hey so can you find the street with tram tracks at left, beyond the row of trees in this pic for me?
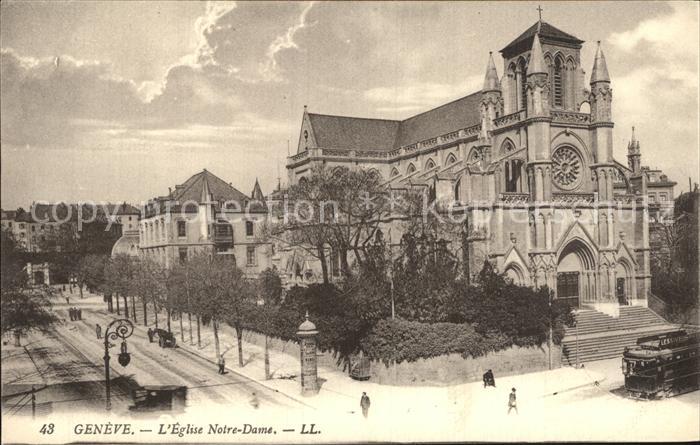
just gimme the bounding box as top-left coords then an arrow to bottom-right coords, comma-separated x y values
2,297 -> 302,411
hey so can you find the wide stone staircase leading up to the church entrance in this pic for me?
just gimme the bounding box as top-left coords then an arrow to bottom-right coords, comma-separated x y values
561,306 -> 678,365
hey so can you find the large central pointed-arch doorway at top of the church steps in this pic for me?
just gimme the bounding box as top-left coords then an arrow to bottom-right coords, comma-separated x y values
557,239 -> 596,307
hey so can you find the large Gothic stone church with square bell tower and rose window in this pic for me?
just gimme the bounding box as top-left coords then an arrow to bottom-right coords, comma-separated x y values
287,21 -> 672,312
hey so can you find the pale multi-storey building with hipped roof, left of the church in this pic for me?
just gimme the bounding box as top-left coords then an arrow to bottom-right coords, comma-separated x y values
138,169 -> 271,276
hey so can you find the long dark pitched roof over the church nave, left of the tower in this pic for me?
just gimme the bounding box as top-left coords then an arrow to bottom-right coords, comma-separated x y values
308,92 -> 481,151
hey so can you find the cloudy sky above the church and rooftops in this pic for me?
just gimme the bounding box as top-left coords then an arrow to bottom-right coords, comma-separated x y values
0,1 -> 700,209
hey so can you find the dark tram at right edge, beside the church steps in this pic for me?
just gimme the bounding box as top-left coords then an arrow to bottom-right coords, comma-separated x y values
622,330 -> 700,399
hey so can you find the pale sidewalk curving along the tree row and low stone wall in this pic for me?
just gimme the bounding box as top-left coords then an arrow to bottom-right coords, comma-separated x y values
75,294 -> 605,415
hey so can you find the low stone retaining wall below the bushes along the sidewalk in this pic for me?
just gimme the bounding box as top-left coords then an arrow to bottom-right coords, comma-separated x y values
243,331 -> 561,386
